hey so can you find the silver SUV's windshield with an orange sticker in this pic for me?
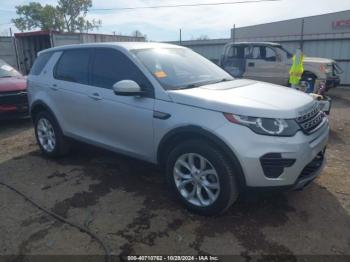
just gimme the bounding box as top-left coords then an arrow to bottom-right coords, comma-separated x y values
133,48 -> 233,90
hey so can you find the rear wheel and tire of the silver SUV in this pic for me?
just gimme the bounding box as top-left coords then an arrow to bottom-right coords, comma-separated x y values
34,111 -> 70,158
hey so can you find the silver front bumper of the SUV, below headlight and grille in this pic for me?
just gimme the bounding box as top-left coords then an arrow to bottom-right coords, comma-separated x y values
216,121 -> 329,189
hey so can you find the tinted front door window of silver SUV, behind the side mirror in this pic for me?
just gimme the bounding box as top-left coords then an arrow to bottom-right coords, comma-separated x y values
91,48 -> 152,91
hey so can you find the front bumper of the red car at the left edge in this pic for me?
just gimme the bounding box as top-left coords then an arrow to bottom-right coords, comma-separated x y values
0,92 -> 29,120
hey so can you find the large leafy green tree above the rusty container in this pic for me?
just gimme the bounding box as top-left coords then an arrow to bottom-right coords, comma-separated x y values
12,0 -> 102,32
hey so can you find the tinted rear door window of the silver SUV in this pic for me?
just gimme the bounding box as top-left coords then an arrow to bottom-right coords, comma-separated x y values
55,49 -> 90,84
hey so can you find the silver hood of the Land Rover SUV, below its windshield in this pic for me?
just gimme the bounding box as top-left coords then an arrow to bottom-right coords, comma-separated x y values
168,79 -> 314,119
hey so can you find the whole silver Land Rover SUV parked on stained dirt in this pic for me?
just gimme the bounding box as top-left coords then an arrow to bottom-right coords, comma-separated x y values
28,43 -> 329,215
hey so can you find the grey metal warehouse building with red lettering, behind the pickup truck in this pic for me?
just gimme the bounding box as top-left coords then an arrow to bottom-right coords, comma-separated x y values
177,10 -> 350,85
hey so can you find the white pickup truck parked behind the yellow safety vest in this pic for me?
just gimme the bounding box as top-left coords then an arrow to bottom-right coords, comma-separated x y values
219,42 -> 342,90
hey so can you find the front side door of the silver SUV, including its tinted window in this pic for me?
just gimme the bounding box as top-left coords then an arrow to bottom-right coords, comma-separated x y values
85,48 -> 154,160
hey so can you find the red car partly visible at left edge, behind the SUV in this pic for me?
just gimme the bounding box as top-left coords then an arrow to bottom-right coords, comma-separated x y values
0,59 -> 29,120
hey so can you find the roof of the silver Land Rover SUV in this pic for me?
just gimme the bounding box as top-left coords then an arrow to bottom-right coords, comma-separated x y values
39,42 -> 185,54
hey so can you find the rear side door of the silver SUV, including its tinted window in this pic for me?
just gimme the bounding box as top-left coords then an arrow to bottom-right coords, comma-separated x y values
50,48 -> 92,138
